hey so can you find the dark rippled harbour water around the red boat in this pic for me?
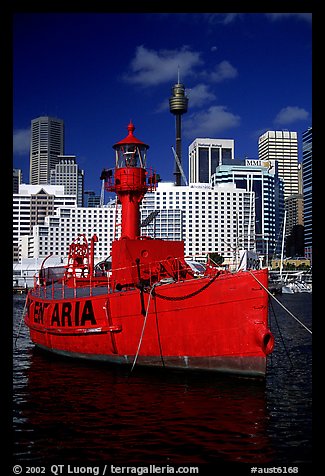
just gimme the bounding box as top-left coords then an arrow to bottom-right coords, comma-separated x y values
11,293 -> 312,474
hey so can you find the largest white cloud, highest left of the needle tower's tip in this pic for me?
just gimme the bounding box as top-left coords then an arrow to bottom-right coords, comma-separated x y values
124,46 -> 202,86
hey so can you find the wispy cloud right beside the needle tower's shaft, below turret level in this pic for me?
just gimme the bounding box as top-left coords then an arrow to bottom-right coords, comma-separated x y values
183,106 -> 240,138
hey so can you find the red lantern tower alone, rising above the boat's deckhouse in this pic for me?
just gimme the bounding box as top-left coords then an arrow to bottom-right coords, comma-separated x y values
111,121 -> 149,240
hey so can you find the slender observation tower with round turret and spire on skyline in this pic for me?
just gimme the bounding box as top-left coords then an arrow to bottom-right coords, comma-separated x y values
169,73 -> 188,185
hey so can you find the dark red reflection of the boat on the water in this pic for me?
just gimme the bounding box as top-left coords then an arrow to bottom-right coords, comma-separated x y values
15,350 -> 273,464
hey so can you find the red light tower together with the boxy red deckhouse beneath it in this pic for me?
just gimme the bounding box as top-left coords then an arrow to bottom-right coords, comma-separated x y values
107,122 -> 187,289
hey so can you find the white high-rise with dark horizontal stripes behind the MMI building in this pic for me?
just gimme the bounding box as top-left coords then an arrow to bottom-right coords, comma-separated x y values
258,131 -> 299,199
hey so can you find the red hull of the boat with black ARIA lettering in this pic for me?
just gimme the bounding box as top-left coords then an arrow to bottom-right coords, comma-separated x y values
25,269 -> 274,376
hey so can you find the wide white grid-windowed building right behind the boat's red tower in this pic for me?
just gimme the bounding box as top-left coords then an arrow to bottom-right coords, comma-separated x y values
141,182 -> 256,262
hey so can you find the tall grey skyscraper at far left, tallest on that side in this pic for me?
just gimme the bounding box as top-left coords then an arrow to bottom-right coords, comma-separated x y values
29,116 -> 64,185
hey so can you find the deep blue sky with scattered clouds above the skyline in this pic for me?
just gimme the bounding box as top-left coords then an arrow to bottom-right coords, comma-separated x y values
13,13 -> 312,194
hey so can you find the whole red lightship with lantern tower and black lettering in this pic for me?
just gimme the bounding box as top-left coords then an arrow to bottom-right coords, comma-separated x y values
25,123 -> 274,377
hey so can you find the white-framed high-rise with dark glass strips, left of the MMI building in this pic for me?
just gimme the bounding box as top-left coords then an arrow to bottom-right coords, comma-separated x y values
188,138 -> 235,184
